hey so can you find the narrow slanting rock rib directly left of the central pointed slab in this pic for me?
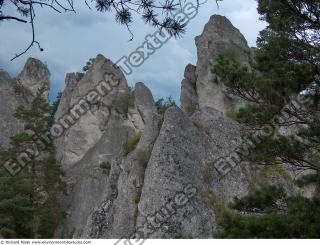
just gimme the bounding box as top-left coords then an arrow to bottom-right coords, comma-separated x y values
86,114 -> 161,238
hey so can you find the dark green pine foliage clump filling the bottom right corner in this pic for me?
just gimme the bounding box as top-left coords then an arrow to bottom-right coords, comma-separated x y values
219,187 -> 320,238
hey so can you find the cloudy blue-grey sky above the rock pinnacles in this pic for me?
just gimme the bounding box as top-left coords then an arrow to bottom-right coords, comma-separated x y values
0,0 -> 265,101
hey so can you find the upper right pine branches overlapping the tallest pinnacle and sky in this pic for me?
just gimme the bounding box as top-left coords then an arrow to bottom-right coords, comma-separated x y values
213,0 -> 320,170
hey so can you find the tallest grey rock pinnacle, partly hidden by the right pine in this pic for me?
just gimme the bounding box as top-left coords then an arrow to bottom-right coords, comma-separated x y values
181,15 -> 252,113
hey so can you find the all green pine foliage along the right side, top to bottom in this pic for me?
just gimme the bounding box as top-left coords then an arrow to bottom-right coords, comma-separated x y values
213,0 -> 320,238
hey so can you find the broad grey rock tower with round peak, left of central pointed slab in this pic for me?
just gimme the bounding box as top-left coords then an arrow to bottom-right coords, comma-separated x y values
55,55 -> 160,238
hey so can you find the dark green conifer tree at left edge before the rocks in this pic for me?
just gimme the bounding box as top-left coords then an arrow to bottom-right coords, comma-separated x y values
0,86 -> 65,238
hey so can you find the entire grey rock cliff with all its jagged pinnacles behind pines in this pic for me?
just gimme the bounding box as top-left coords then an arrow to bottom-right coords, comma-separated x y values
0,16 -> 308,238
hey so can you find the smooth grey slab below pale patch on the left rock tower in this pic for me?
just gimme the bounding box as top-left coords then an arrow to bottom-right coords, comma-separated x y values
56,114 -> 128,238
